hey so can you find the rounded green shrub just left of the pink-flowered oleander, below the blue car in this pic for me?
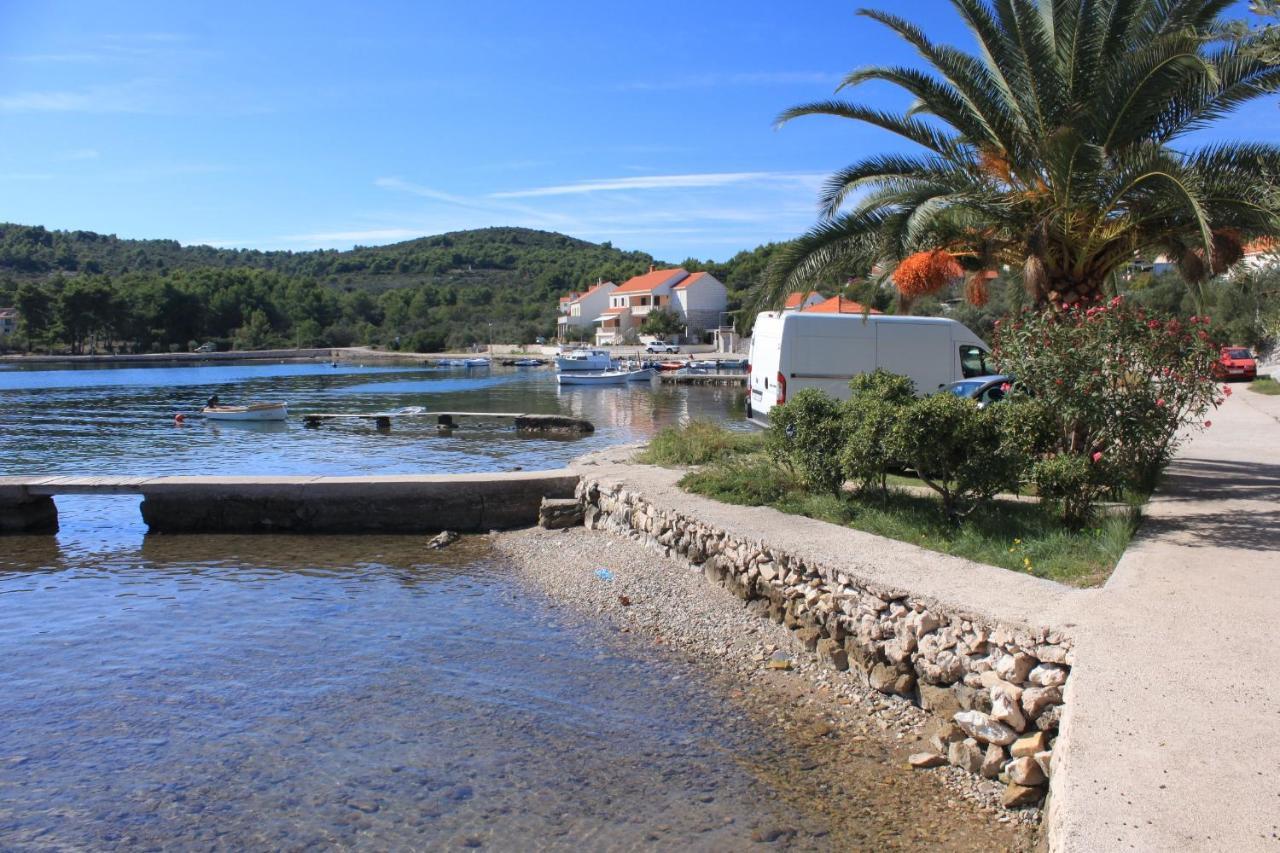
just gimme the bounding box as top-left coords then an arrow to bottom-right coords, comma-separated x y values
886,394 -> 1020,520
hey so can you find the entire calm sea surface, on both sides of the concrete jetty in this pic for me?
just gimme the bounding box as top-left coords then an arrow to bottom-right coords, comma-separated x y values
0,364 -> 820,849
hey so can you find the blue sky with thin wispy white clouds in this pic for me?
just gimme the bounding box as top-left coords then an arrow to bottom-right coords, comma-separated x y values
0,0 -> 1280,261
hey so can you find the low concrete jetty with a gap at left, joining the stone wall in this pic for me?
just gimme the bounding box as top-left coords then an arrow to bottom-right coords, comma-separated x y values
0,469 -> 579,533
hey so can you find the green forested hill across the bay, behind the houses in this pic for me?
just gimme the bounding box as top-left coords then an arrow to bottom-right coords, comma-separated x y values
0,224 -> 774,352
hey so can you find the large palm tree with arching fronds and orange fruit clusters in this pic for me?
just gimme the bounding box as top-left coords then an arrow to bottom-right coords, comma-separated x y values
756,0 -> 1280,307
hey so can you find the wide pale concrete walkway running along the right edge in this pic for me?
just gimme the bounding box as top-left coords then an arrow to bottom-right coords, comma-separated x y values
1050,386 -> 1280,852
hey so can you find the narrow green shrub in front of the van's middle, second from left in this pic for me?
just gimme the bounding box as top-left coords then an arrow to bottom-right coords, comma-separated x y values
840,369 -> 915,498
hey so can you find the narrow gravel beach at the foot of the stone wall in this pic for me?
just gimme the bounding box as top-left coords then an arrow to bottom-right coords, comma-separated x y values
492,528 -> 1038,850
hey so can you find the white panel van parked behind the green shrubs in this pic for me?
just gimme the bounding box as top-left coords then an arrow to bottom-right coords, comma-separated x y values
746,311 -> 995,427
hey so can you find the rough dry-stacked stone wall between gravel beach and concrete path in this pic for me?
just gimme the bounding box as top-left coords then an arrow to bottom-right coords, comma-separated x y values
577,473 -> 1073,808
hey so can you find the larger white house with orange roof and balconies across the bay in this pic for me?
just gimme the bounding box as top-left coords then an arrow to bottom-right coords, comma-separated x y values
595,269 -> 728,345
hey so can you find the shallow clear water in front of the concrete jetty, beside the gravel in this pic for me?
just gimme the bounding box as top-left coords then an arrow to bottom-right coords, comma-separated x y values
0,535 -> 860,849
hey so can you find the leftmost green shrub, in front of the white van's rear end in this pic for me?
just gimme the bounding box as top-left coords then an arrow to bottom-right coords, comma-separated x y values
765,388 -> 846,494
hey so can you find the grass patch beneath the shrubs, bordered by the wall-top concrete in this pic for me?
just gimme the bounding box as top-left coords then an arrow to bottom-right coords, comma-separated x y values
680,453 -> 1138,587
